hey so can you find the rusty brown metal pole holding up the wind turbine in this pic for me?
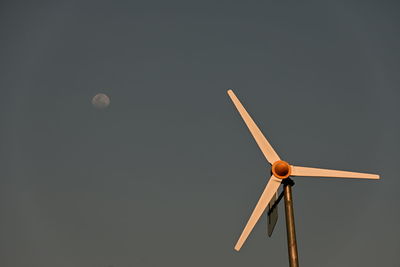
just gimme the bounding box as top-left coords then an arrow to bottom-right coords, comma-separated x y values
283,178 -> 299,267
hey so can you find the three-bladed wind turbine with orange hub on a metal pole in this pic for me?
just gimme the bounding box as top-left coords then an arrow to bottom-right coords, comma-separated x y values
228,90 -> 380,267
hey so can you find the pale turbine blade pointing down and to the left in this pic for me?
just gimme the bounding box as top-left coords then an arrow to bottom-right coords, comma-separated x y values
235,175 -> 282,251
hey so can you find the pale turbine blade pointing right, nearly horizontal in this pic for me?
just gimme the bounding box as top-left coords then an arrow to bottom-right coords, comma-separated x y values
291,166 -> 380,179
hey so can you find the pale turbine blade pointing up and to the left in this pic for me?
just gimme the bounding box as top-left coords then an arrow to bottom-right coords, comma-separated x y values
228,90 -> 280,164
